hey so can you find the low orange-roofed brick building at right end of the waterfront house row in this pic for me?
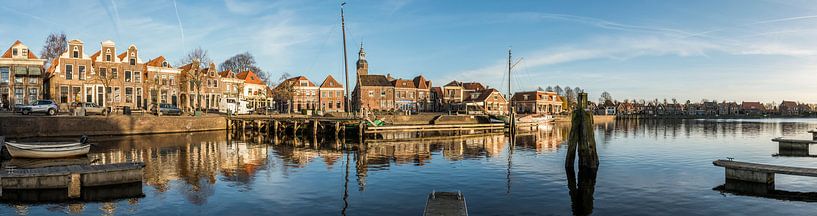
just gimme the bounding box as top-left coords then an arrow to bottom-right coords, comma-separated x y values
511,91 -> 562,114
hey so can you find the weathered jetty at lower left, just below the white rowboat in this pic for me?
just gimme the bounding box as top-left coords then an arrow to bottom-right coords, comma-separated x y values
0,162 -> 145,197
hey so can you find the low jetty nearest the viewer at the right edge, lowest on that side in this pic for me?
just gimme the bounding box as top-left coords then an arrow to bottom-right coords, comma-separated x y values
712,160 -> 817,186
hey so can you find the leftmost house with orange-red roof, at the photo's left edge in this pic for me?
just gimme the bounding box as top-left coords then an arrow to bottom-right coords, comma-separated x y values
0,40 -> 45,109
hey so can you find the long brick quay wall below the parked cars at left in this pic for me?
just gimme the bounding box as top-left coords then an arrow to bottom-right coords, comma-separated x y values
0,116 -> 227,138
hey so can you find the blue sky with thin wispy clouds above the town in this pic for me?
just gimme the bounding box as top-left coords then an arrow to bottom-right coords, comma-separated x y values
0,0 -> 817,103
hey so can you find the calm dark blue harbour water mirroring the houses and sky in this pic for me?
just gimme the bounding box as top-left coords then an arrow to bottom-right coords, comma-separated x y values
0,120 -> 817,215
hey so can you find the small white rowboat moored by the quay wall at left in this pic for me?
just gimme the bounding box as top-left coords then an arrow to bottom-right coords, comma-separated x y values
0,137 -> 91,158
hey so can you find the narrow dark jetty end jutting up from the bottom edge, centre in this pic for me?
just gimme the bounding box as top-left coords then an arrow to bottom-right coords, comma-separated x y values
423,192 -> 468,216
